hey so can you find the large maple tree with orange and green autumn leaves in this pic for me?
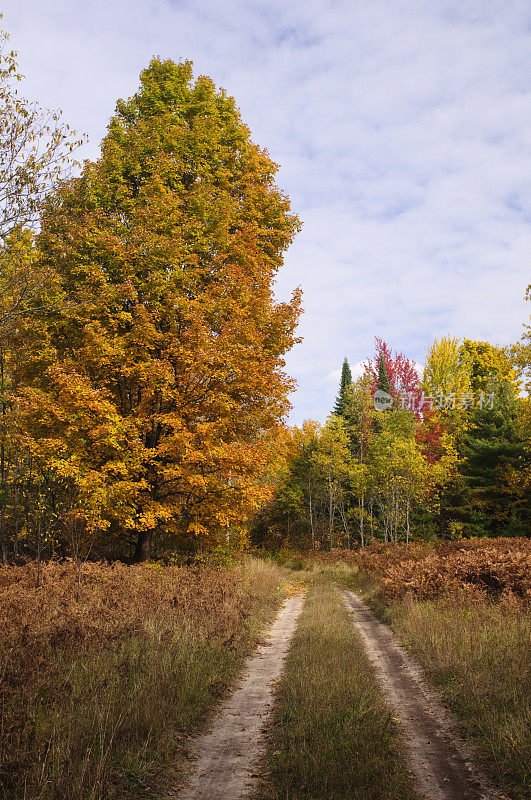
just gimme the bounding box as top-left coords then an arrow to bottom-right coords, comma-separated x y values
18,58 -> 300,560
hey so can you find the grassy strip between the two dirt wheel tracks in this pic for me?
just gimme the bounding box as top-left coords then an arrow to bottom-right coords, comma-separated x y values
258,582 -> 415,800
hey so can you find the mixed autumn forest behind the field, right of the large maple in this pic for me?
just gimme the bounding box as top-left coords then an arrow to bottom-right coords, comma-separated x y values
253,332 -> 531,549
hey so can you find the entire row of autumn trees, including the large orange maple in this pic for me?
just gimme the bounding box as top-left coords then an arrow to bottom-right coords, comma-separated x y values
0,25 -> 531,563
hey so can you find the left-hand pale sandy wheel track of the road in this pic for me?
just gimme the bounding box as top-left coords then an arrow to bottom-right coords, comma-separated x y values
166,595 -> 304,800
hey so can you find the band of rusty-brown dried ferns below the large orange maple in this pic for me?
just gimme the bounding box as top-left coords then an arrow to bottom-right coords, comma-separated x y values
0,562 -> 254,647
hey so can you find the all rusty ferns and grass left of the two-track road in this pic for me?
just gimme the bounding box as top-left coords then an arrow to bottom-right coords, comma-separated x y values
0,561 -> 281,800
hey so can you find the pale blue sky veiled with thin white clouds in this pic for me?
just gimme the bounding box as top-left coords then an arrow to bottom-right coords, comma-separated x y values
2,0 -> 531,422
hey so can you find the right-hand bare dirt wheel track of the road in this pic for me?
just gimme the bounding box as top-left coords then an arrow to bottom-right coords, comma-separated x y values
344,592 -> 503,800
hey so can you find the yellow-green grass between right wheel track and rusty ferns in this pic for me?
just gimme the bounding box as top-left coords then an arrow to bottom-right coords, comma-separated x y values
389,598 -> 531,800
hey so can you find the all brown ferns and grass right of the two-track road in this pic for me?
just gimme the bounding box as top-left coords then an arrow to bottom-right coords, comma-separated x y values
290,539 -> 531,800
